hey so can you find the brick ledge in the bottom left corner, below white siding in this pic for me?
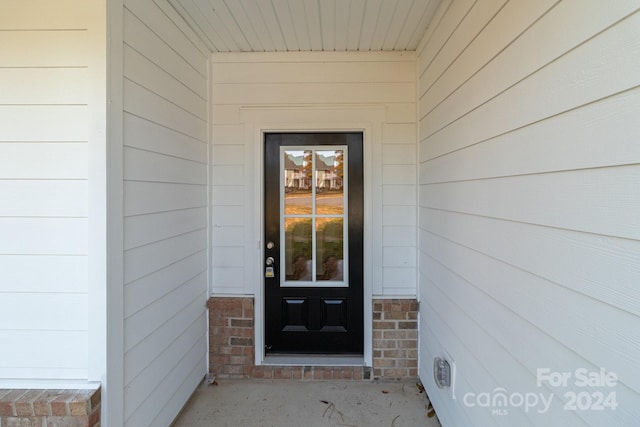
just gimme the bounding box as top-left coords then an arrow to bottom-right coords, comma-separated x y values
0,389 -> 101,427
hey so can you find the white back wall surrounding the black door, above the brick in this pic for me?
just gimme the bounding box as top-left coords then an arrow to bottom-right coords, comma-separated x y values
211,52 -> 417,300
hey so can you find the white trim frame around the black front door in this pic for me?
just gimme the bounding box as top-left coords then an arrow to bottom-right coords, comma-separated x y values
252,123 -> 381,366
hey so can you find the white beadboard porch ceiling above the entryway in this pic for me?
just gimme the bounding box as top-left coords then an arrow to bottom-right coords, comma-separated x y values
169,0 -> 441,52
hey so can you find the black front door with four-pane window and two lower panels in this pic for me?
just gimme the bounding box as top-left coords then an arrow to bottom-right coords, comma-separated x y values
263,133 -> 363,354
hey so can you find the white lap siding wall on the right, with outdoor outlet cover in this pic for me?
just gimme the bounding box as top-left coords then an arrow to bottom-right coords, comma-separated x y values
418,0 -> 640,426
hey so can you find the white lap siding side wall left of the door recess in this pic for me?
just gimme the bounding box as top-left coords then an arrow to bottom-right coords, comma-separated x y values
123,0 -> 208,427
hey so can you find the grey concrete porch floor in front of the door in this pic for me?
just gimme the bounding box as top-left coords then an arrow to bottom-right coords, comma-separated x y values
173,379 -> 440,427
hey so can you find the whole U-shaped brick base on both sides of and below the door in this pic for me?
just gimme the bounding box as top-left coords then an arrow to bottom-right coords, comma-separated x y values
210,297 -> 418,382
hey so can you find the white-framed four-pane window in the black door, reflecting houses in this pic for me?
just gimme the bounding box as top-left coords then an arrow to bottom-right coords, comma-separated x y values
280,146 -> 348,286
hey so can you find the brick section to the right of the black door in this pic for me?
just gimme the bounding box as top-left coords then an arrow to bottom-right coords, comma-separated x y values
373,299 -> 418,379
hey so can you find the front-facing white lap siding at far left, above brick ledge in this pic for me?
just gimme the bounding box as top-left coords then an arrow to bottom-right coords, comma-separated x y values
0,0 -> 91,380
